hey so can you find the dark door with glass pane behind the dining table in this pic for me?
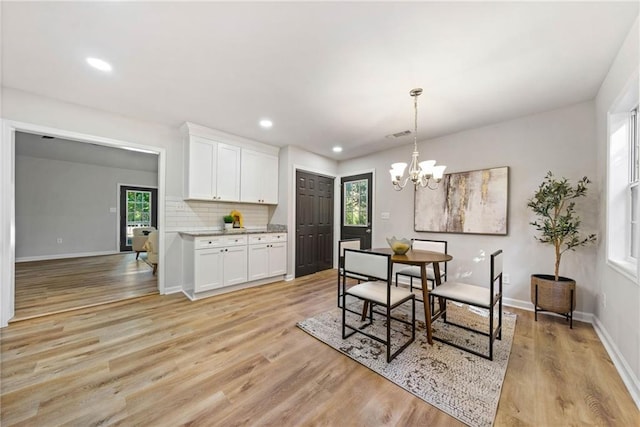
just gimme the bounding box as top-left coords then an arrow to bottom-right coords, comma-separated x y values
340,173 -> 373,249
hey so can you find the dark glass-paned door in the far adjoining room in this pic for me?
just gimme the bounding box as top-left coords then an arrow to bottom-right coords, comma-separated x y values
120,185 -> 158,252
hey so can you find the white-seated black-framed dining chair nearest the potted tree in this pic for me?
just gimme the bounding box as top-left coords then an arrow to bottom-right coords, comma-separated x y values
429,249 -> 502,360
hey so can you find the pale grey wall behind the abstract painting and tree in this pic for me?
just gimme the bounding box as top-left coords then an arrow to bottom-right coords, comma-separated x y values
339,102 -> 599,314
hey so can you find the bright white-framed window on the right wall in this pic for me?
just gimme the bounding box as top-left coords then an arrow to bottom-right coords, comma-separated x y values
607,99 -> 640,281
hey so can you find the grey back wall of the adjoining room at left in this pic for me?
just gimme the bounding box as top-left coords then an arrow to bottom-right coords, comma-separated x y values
15,156 -> 158,261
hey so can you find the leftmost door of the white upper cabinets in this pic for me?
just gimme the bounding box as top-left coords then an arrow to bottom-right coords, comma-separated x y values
185,136 -> 217,200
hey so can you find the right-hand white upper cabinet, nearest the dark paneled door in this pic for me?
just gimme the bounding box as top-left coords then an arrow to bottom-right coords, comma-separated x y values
240,148 -> 278,205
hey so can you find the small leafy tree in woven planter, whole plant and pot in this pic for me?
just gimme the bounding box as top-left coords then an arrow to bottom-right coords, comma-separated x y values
527,172 -> 596,327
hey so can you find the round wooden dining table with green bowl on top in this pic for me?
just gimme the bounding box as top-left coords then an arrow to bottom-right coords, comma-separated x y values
371,248 -> 453,344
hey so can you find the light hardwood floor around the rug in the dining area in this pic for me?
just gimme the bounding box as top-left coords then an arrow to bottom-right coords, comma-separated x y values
0,270 -> 640,427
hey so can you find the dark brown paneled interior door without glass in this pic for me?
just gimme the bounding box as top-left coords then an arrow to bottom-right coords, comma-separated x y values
296,171 -> 333,277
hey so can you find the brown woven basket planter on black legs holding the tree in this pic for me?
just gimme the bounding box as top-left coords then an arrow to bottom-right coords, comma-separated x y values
531,274 -> 576,327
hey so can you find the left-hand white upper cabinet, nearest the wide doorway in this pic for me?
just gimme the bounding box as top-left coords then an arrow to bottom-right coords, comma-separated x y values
184,136 -> 240,202
